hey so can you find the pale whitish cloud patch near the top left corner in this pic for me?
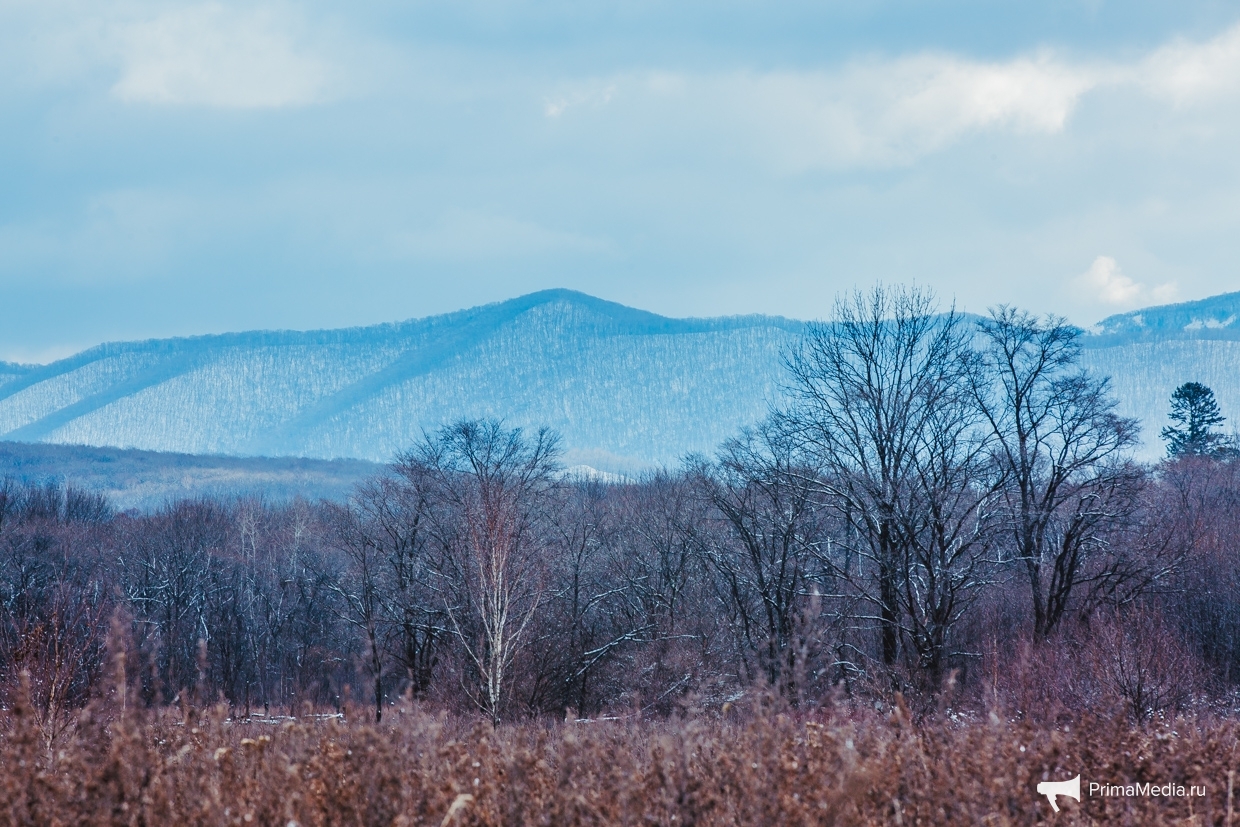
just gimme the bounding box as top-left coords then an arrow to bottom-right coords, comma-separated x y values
112,4 -> 329,109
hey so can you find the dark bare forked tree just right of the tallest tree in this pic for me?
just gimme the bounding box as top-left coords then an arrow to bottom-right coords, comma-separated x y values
973,307 -> 1141,639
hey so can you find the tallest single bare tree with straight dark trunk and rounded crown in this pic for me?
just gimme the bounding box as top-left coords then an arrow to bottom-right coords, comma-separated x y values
780,286 -> 967,666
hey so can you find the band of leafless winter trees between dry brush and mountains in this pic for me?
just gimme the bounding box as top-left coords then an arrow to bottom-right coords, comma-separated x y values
0,288 -> 1240,722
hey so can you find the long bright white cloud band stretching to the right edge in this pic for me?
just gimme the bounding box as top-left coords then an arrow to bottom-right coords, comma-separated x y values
543,25 -> 1240,172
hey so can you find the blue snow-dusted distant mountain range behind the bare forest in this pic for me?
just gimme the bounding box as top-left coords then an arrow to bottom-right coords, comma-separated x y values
0,290 -> 1240,474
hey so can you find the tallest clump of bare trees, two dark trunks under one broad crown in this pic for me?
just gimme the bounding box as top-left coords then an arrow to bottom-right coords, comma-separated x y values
776,288 -> 1002,682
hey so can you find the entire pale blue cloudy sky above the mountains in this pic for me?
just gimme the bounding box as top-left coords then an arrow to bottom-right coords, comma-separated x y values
0,0 -> 1240,362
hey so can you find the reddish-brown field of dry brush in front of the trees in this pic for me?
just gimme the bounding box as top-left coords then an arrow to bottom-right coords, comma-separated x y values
0,679 -> 1240,827
